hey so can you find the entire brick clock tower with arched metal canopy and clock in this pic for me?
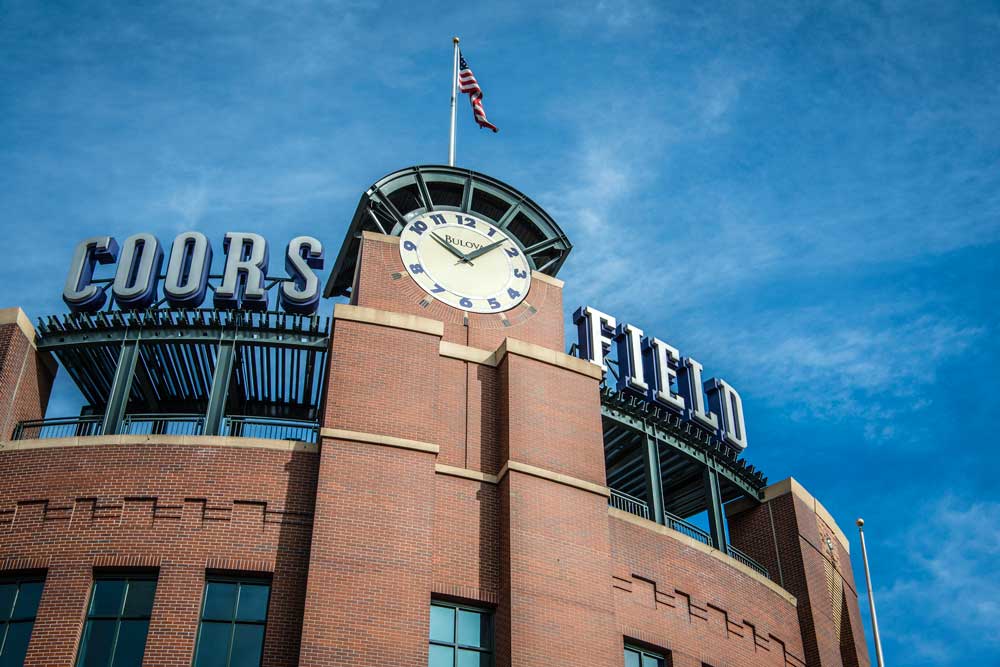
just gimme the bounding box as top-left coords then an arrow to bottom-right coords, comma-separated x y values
300,166 -> 621,667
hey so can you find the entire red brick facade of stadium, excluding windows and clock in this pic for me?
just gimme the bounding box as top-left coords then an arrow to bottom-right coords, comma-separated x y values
0,234 -> 868,667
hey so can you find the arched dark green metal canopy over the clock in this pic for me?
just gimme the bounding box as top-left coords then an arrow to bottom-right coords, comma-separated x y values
324,165 -> 573,297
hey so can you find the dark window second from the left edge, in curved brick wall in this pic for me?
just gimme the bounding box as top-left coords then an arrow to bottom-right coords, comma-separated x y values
76,574 -> 156,667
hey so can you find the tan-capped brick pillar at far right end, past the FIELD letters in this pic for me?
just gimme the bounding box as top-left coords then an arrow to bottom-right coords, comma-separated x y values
727,478 -> 870,667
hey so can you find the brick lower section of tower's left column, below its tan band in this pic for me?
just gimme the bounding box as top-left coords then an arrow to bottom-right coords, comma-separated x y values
299,438 -> 436,667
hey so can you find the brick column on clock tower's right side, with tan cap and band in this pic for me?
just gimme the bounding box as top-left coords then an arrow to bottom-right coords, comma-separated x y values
497,339 -> 622,667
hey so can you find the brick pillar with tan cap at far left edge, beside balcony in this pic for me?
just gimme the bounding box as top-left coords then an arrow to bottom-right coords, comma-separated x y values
0,308 -> 57,440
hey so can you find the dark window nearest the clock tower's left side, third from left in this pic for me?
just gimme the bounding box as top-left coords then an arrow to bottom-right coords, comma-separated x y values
194,576 -> 271,667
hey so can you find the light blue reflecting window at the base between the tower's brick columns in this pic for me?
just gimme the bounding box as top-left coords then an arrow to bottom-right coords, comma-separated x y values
427,602 -> 493,667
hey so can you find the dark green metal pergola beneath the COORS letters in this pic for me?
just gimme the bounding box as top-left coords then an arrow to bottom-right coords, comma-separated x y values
37,308 -> 330,434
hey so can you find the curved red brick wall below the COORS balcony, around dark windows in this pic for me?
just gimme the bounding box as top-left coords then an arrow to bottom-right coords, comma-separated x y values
0,439 -> 318,667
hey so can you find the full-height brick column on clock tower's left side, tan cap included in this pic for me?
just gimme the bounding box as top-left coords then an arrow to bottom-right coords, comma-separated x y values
299,305 -> 442,667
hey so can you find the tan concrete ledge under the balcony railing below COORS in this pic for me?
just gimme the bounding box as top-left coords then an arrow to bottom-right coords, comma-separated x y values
0,435 -> 319,454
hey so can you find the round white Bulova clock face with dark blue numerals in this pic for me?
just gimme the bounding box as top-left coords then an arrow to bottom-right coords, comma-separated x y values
399,211 -> 531,313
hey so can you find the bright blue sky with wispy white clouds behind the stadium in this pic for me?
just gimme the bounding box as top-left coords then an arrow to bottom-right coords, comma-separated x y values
0,0 -> 1000,667
